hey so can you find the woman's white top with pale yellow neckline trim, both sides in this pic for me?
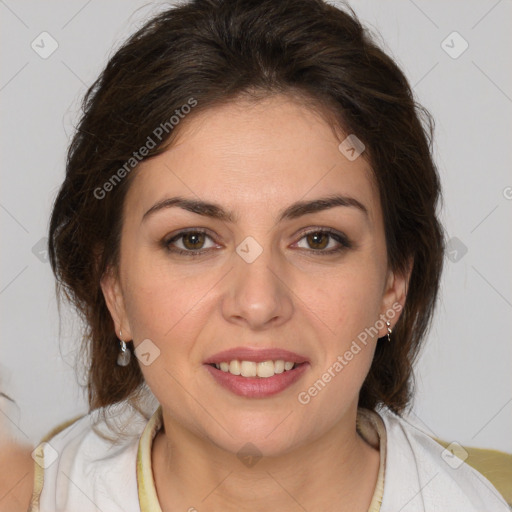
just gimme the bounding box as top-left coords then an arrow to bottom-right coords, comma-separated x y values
29,407 -> 510,512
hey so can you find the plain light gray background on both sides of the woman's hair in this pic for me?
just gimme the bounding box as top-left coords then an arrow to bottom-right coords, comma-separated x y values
0,0 -> 512,452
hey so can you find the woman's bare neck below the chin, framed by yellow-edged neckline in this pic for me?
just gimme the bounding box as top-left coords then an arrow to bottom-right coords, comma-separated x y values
152,408 -> 379,512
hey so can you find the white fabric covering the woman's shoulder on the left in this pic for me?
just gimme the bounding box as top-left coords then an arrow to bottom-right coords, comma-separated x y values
30,404 -> 148,512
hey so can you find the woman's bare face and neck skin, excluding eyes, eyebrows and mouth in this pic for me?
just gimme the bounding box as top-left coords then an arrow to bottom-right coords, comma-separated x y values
102,95 -> 408,512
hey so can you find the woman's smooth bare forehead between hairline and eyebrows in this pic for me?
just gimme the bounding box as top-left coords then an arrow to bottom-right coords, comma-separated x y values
126,96 -> 379,226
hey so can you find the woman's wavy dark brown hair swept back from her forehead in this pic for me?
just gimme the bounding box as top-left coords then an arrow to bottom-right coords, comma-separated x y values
49,0 -> 444,420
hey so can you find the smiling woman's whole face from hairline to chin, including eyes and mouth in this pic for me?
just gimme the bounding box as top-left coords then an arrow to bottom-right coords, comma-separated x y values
102,96 -> 405,455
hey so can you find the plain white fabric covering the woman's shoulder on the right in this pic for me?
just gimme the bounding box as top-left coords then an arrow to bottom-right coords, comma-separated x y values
378,408 -> 509,512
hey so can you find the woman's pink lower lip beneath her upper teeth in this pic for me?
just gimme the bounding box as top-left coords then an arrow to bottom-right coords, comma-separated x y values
205,363 -> 309,398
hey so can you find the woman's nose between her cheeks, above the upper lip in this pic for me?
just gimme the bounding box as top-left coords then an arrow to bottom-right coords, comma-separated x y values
222,242 -> 293,330
